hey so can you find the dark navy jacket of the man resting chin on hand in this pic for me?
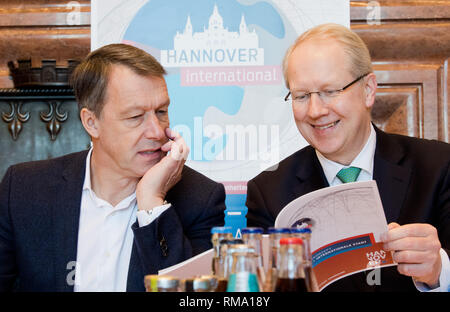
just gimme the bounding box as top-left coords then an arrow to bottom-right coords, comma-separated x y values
0,151 -> 225,291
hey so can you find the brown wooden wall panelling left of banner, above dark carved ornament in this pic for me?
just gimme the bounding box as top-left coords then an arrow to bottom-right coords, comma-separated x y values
0,0 -> 90,88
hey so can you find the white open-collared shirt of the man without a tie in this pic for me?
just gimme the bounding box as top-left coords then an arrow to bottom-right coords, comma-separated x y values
74,148 -> 170,292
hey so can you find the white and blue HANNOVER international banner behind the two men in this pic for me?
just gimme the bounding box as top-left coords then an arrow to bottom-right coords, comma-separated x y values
91,0 -> 350,234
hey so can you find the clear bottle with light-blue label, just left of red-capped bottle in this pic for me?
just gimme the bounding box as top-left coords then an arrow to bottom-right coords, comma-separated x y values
227,245 -> 261,292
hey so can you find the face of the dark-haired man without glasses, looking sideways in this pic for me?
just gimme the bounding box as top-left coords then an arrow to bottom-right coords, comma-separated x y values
90,65 -> 170,178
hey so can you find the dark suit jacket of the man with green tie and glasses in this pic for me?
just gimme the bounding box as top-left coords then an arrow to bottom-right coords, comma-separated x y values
246,128 -> 450,291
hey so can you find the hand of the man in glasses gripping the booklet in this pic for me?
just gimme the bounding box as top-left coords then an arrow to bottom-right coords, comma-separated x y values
381,223 -> 442,287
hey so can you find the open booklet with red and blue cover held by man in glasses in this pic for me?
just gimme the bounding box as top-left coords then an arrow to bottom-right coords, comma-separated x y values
275,181 -> 396,290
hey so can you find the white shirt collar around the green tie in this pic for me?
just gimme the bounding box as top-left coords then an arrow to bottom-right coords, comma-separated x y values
315,124 -> 377,185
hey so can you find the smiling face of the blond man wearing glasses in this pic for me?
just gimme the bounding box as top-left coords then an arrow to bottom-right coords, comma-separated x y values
287,39 -> 376,165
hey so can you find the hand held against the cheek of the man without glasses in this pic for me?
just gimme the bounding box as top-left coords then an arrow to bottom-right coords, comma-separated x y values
136,128 -> 189,210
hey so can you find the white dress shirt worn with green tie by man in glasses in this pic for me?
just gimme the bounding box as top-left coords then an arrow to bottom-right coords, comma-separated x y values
316,124 -> 450,292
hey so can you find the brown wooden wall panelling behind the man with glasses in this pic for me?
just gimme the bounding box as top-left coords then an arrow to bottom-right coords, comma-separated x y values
350,0 -> 450,142
